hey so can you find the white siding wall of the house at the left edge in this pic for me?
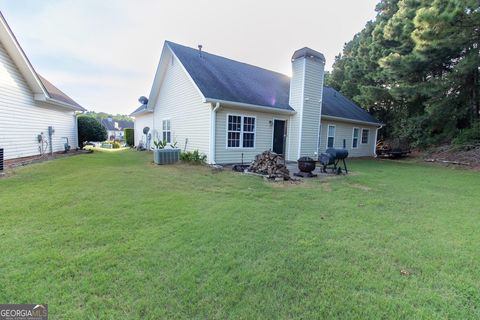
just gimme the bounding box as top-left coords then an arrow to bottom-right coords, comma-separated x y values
0,44 -> 78,159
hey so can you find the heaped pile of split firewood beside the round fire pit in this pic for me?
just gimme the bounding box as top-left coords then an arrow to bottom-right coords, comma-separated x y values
248,151 -> 290,180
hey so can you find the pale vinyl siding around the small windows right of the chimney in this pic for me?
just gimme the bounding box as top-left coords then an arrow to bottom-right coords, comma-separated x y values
319,119 -> 376,157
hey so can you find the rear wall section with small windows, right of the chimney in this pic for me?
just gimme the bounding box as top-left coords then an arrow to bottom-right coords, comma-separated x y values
319,119 -> 377,157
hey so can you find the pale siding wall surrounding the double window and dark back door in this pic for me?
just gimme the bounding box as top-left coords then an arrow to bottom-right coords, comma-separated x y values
215,106 -> 290,164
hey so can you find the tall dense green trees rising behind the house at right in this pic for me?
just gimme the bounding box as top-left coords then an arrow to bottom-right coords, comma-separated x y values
328,0 -> 480,145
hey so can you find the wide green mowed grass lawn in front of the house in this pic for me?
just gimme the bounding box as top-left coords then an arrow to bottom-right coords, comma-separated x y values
0,151 -> 480,319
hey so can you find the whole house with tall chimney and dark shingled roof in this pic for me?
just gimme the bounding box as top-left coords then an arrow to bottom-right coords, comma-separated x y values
132,41 -> 382,163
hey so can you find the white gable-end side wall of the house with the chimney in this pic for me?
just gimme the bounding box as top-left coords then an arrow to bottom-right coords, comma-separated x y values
152,50 -> 211,158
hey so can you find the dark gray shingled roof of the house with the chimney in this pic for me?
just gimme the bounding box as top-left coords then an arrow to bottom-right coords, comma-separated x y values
164,41 -> 380,124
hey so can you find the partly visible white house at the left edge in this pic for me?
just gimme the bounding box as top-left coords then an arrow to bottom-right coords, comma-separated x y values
0,13 -> 85,159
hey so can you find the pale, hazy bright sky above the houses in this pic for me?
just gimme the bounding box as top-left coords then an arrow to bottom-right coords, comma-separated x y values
0,0 -> 378,114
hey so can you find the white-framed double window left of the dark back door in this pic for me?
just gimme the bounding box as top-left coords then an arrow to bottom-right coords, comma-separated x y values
227,115 -> 255,148
